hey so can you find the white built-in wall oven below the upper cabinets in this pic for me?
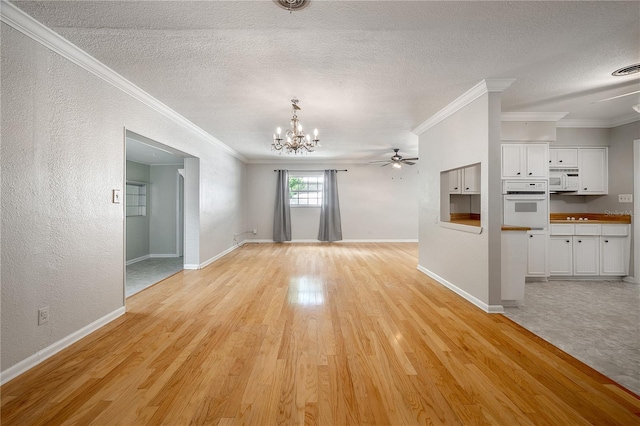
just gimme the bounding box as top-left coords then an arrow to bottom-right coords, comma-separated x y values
502,180 -> 549,229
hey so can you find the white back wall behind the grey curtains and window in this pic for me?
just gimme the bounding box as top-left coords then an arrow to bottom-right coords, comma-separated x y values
247,160 -> 421,241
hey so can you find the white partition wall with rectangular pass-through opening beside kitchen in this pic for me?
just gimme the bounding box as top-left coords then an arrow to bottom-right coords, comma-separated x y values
419,92 -> 502,306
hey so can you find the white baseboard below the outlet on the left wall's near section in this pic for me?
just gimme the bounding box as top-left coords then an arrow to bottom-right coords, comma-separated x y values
0,306 -> 126,385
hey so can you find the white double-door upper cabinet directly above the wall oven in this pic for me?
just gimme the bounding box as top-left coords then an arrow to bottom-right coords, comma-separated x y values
502,143 -> 549,179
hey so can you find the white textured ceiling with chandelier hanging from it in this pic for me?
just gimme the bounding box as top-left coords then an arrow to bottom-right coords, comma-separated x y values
14,0 -> 640,161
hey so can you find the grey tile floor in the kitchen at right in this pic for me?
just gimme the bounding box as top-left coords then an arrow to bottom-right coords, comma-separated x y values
505,281 -> 640,394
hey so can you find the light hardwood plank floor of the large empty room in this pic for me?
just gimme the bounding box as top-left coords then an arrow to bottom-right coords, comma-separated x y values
0,243 -> 640,425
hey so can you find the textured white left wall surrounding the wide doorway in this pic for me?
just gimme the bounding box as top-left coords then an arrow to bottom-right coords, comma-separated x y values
0,22 -> 246,380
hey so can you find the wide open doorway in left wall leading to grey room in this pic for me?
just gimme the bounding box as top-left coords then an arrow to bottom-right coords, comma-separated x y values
124,130 -> 199,298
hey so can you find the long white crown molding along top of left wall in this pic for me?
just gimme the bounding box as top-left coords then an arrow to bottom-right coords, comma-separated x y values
0,0 -> 247,163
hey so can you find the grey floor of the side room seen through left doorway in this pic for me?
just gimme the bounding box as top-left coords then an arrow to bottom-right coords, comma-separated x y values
125,257 -> 183,297
